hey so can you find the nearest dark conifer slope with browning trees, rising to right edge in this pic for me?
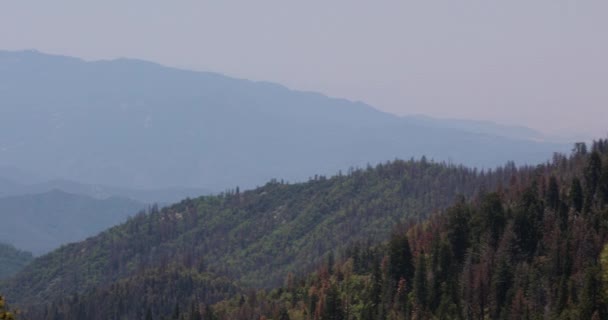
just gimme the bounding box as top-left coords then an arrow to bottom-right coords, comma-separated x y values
207,140 -> 608,320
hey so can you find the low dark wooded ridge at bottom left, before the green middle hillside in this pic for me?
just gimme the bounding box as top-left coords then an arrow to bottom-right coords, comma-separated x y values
35,265 -> 238,320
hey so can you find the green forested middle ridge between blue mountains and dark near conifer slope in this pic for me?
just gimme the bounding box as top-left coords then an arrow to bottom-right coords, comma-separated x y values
0,159 -> 517,317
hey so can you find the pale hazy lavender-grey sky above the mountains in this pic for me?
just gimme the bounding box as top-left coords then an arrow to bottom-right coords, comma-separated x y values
0,0 -> 608,137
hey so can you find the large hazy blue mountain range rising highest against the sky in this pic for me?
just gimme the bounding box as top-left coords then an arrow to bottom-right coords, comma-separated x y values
0,51 -> 569,190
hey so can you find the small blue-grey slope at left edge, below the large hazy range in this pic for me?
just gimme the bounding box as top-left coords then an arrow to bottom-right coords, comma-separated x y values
0,190 -> 143,255
